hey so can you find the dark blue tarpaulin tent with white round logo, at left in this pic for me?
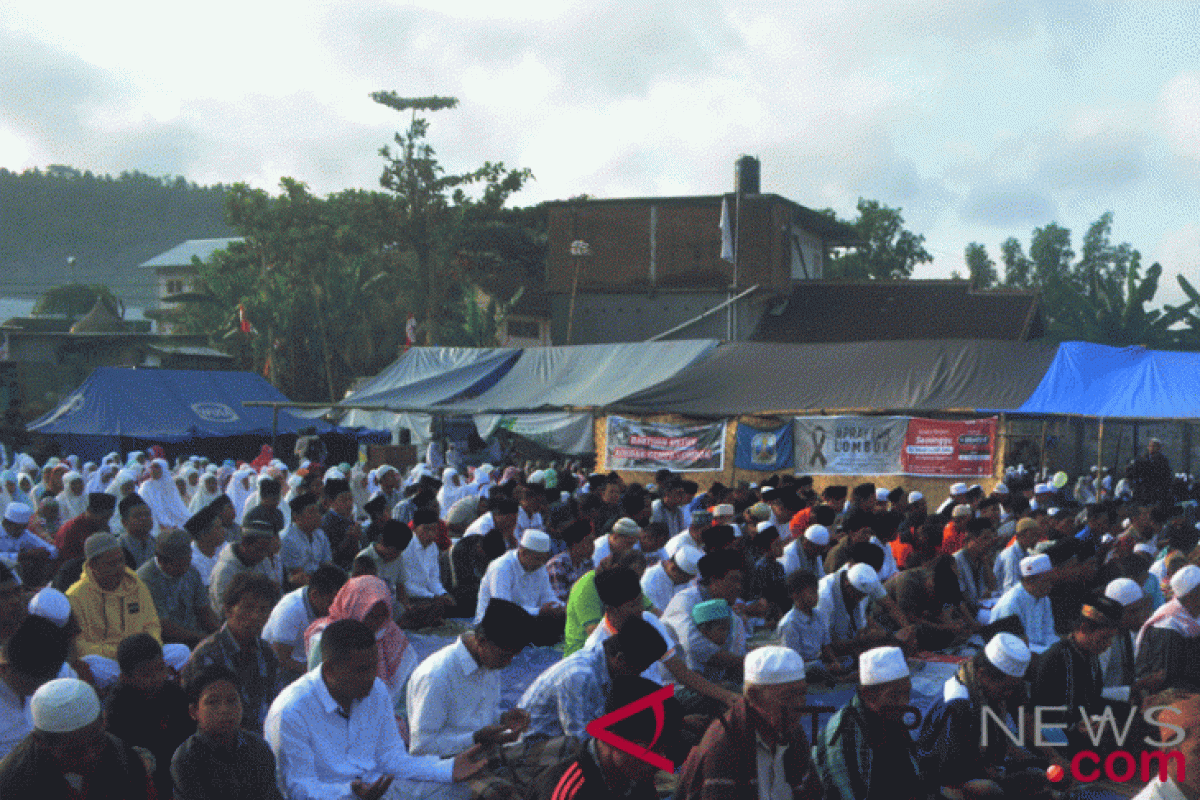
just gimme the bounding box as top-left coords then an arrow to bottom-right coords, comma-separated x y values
28,367 -> 332,462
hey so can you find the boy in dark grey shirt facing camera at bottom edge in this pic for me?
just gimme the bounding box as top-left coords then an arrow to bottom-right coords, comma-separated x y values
171,666 -> 282,800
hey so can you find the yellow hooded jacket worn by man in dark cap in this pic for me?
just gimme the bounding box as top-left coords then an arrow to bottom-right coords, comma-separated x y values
66,565 -> 162,660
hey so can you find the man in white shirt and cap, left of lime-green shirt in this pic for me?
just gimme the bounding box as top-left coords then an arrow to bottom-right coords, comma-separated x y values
475,528 -> 566,645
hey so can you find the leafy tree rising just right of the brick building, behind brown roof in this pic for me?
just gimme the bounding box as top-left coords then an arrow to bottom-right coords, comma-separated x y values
826,198 -> 934,281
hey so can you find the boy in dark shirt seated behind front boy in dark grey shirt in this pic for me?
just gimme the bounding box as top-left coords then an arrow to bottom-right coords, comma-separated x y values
104,633 -> 196,798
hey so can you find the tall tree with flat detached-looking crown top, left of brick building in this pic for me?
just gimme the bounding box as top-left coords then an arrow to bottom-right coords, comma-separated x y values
371,91 -> 533,344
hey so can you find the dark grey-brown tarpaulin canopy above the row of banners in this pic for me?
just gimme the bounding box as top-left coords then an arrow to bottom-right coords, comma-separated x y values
614,338 -> 1057,417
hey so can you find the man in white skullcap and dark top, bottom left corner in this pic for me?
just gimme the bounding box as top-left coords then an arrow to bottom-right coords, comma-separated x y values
0,678 -> 155,800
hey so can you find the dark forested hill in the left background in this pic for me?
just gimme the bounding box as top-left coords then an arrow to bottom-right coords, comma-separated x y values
0,166 -> 234,306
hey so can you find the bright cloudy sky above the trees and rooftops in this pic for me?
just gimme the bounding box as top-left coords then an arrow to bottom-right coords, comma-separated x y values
0,0 -> 1200,300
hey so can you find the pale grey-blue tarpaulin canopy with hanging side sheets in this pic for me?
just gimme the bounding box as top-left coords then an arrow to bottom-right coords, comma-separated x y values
331,339 -> 718,453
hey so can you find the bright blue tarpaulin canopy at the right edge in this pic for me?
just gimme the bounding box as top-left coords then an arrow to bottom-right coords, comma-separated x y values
986,342 -> 1200,420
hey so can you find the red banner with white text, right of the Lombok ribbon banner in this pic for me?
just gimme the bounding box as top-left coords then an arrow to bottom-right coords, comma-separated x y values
900,416 -> 996,477
